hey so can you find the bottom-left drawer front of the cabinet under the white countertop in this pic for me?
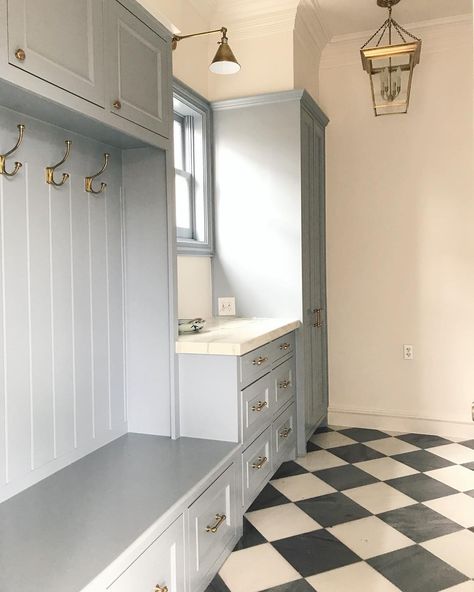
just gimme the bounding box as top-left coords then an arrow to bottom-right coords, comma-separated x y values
242,427 -> 272,508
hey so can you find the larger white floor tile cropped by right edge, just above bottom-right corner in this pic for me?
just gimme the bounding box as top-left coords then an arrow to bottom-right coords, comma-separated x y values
421,530 -> 474,578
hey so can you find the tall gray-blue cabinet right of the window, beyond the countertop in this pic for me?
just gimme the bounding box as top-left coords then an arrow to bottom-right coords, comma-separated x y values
213,91 -> 328,454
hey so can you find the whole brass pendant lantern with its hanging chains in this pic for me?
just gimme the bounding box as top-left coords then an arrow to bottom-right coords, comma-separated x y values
360,0 -> 421,117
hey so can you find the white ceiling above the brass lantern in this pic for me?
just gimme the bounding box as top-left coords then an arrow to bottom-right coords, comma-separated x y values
317,0 -> 472,38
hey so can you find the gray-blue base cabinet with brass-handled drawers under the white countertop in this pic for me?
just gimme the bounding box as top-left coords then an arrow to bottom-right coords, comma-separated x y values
179,332 -> 296,510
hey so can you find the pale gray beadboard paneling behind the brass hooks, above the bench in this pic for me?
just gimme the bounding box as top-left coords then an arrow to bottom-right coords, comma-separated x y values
0,108 -> 127,501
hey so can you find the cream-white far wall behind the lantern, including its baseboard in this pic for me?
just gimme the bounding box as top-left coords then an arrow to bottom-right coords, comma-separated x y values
320,16 -> 474,435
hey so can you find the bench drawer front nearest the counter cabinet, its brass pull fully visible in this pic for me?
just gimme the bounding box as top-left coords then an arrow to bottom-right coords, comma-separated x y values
188,465 -> 236,590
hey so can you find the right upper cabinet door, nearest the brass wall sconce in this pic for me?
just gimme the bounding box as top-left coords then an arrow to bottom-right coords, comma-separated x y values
106,0 -> 171,137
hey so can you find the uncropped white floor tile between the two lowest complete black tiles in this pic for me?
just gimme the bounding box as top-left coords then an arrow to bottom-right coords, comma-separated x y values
328,516 -> 414,559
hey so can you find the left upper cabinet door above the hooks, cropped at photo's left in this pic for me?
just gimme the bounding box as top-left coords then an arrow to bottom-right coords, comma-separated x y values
8,0 -> 105,106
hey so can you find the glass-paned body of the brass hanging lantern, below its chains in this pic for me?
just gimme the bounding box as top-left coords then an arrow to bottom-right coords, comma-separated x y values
360,40 -> 421,117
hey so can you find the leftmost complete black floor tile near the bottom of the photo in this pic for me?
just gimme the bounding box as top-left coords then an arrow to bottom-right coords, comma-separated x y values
272,530 -> 360,577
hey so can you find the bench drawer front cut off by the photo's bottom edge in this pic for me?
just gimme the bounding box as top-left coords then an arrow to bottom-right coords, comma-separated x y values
107,516 -> 184,592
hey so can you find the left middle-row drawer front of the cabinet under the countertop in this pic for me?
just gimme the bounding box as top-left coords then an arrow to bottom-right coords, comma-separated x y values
241,374 -> 275,443
